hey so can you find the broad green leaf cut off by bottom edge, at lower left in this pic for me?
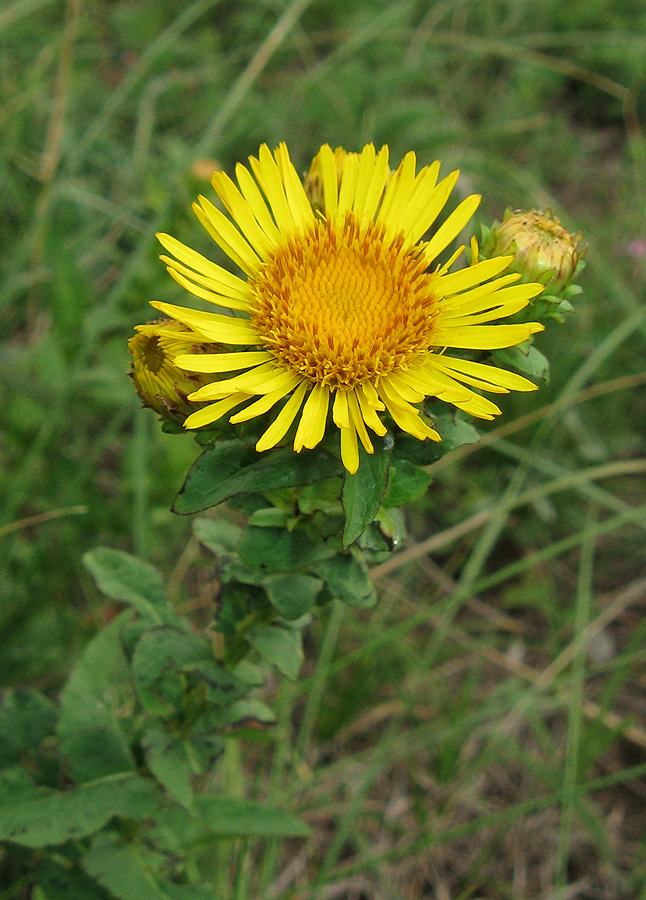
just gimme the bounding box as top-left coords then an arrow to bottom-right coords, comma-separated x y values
83,832 -> 172,900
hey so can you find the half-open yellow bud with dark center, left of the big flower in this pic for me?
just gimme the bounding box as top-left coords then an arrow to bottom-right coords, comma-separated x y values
128,319 -> 220,425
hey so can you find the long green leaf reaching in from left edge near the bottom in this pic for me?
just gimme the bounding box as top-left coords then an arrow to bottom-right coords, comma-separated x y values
0,772 -> 161,848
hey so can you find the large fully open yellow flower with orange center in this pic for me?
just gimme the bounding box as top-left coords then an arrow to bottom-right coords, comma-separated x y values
152,144 -> 543,473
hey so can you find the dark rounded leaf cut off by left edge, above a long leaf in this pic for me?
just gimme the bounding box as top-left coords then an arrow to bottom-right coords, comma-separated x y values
0,688 -> 56,768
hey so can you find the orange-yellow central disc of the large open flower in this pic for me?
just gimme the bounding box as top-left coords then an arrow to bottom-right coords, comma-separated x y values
252,214 -> 439,389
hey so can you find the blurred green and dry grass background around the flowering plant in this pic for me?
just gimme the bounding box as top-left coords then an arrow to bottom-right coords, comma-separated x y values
0,0 -> 646,900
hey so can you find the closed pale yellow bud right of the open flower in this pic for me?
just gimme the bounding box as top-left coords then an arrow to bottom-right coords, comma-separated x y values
484,209 -> 586,294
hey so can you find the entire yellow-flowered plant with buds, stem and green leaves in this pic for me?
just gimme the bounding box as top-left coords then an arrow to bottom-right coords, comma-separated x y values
0,144 -> 582,900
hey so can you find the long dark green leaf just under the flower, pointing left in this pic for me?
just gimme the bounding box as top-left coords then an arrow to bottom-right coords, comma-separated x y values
173,440 -> 340,515
